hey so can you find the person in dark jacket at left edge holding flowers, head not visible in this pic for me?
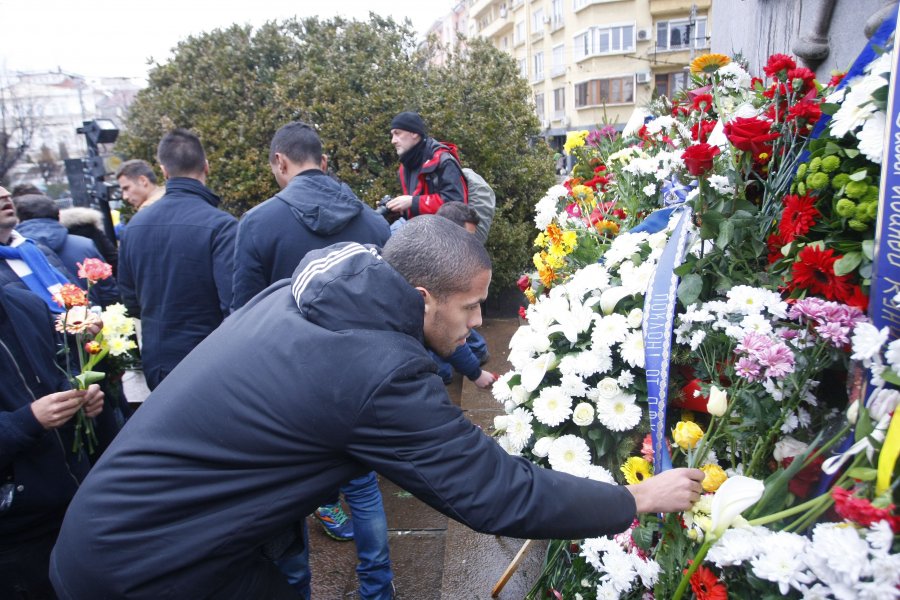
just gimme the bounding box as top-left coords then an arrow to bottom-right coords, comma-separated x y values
0,286 -> 103,600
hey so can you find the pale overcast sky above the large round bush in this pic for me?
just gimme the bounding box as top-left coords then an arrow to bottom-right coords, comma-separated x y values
0,0 -> 453,78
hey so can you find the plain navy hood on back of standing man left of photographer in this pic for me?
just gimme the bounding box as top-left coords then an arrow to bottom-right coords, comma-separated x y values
275,174 -> 364,235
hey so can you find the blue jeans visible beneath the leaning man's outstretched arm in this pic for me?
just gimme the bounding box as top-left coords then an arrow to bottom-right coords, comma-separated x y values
278,471 -> 394,600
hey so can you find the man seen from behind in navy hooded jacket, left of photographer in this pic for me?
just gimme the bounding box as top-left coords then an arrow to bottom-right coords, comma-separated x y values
232,121 -> 391,309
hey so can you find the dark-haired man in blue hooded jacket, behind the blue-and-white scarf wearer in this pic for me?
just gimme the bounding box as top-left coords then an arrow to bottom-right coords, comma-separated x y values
14,194 -> 119,307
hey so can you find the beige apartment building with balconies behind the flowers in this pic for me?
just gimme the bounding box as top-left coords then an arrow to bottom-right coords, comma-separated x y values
468,0 -> 712,148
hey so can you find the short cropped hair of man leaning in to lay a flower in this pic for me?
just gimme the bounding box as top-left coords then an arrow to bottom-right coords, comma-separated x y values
382,215 -> 491,300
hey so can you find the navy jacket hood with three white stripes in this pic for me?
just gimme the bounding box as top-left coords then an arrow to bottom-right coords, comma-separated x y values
291,242 -> 425,342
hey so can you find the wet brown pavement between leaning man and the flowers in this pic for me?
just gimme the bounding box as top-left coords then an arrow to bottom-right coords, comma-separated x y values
308,318 -> 544,600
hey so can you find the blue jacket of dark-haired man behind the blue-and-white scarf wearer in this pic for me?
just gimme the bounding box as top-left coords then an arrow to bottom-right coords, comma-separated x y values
16,219 -> 120,308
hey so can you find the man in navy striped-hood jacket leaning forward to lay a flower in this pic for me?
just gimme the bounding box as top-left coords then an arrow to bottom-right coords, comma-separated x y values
50,216 -> 704,600
